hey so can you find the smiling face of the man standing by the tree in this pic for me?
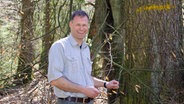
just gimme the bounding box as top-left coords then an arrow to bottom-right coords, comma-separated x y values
69,16 -> 89,41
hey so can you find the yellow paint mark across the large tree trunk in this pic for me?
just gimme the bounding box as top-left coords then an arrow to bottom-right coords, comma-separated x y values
136,4 -> 175,12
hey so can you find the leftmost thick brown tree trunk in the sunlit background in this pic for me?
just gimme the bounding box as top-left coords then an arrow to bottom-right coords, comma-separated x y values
15,0 -> 34,84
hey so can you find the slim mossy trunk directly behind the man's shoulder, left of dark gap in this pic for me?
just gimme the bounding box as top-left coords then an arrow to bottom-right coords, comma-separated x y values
89,0 -> 107,78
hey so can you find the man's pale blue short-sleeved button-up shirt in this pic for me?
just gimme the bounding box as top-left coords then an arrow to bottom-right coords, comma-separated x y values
48,35 -> 94,98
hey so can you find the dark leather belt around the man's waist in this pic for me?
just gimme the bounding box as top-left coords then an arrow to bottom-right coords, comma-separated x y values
59,97 -> 93,103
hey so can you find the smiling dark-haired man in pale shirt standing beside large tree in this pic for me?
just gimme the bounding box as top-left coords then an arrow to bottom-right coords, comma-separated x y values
48,10 -> 119,104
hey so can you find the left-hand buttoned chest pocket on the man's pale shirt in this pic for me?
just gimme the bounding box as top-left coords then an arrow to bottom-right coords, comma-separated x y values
65,56 -> 79,72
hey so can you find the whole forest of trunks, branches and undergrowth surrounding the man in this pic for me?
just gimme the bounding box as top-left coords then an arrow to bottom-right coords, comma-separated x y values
0,0 -> 184,104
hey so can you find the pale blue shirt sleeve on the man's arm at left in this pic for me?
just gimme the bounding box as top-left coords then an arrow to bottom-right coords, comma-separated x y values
48,43 -> 64,83
